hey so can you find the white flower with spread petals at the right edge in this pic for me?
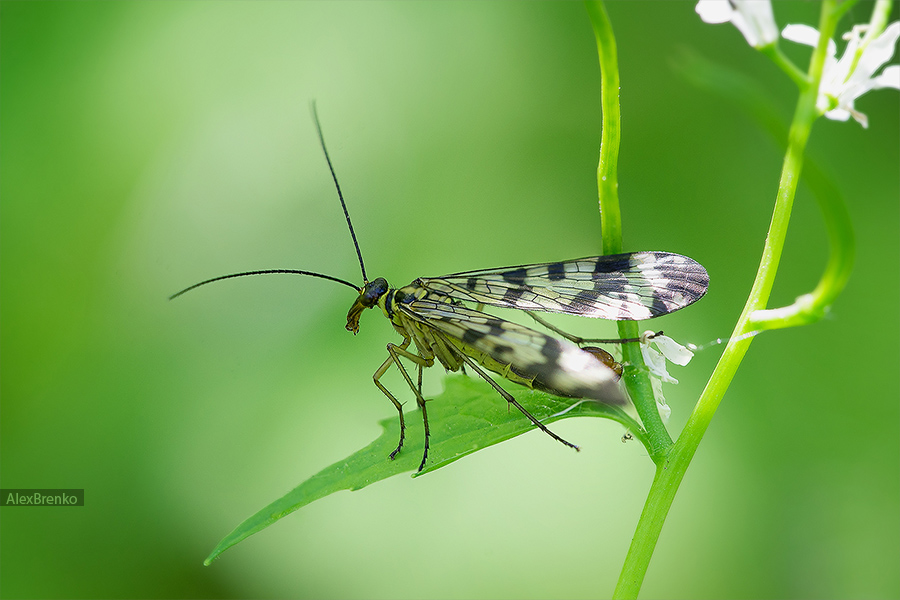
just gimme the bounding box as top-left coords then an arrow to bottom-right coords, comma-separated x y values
781,21 -> 900,127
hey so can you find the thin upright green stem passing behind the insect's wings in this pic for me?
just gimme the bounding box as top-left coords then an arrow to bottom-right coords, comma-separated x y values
585,0 -> 672,463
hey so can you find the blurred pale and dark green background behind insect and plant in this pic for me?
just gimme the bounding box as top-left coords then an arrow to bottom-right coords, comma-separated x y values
0,2 -> 900,598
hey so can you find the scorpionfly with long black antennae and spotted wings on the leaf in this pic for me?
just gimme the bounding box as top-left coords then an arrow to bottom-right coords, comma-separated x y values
170,104 -> 709,471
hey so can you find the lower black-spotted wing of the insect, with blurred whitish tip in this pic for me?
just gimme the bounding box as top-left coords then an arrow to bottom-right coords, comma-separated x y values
399,300 -> 627,404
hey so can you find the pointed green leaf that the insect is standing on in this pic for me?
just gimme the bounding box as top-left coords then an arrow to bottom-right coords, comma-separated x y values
204,375 -> 646,565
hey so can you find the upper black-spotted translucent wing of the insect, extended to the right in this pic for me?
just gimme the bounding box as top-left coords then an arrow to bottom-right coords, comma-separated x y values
416,252 -> 709,321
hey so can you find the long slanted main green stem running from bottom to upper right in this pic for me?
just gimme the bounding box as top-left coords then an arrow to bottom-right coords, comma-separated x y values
613,0 -> 837,598
